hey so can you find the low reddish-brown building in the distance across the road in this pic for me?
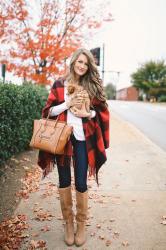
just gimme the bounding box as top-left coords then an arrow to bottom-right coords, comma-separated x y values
116,86 -> 139,101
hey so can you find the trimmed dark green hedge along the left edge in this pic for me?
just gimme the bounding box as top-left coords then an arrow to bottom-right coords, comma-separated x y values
0,82 -> 48,165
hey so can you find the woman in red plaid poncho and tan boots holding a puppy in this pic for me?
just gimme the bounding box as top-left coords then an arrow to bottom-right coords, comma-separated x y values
38,49 -> 109,246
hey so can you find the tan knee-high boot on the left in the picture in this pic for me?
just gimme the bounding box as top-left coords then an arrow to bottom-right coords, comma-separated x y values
59,186 -> 74,246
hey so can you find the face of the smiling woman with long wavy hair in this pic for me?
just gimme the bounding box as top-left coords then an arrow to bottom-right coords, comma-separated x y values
74,54 -> 88,77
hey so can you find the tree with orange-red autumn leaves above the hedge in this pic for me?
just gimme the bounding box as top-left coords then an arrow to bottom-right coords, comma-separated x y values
0,0 -> 111,84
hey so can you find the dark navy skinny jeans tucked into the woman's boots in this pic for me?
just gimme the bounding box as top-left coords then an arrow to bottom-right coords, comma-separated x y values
57,135 -> 88,193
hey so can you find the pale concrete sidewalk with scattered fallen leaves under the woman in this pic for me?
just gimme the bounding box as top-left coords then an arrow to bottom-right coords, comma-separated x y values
15,114 -> 166,250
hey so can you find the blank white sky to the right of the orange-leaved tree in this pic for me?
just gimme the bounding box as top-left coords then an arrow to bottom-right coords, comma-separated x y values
88,0 -> 166,89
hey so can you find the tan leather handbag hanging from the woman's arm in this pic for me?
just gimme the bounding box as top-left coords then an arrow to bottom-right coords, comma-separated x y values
30,115 -> 73,154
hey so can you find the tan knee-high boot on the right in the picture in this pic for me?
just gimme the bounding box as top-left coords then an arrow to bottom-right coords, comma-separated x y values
75,191 -> 88,246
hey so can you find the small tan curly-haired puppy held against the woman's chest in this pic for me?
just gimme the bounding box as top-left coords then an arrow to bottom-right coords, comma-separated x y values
67,83 -> 90,113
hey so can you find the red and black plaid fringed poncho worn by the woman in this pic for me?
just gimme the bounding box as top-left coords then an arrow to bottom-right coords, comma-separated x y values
38,79 -> 109,183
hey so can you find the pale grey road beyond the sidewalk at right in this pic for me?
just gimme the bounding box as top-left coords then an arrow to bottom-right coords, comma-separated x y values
109,101 -> 166,151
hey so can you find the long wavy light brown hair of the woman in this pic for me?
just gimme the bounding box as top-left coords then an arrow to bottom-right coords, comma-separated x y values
67,48 -> 107,106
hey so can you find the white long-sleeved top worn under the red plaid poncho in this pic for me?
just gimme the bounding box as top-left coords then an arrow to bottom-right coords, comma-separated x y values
50,87 -> 96,141
